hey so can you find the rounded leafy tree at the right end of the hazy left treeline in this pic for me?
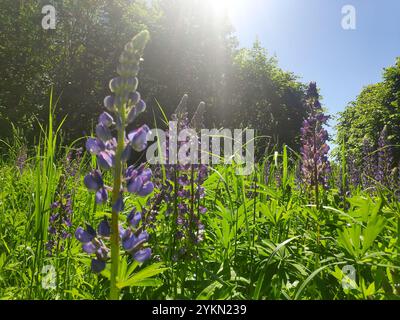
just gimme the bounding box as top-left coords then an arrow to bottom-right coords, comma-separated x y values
222,41 -> 306,156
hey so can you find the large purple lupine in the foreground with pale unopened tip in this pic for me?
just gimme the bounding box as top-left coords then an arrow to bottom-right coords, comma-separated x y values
75,31 -> 154,278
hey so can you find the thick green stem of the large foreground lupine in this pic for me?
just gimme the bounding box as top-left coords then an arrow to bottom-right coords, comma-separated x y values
110,105 -> 125,300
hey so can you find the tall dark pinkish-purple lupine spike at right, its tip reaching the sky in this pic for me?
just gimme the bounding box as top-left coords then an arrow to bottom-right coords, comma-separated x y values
301,82 -> 330,192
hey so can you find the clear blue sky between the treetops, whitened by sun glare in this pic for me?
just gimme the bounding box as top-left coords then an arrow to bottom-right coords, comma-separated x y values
228,0 -> 400,134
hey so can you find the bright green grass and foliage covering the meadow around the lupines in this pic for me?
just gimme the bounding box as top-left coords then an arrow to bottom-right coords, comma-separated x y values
0,110 -> 400,299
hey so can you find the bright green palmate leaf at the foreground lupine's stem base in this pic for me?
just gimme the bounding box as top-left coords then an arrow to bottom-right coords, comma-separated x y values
117,263 -> 168,289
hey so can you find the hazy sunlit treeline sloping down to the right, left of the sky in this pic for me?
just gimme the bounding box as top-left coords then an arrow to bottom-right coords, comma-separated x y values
0,0 -> 306,156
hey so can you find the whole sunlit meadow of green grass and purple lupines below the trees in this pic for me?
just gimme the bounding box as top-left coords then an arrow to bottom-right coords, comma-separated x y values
0,0 -> 400,300
